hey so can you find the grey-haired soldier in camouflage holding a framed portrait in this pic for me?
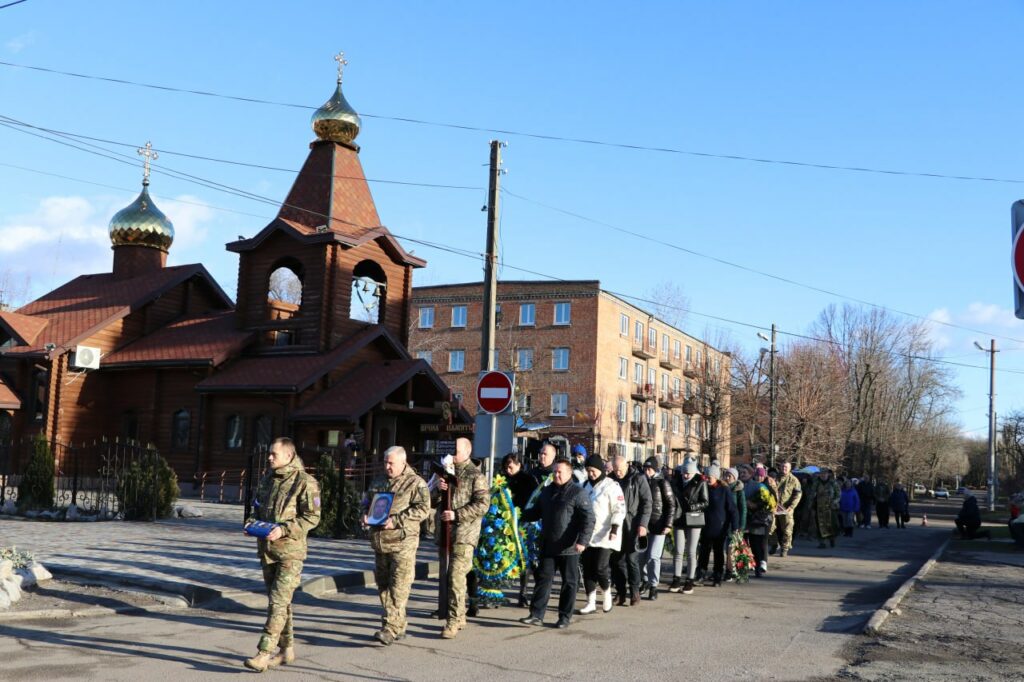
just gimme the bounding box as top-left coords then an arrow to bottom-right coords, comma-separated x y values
362,445 -> 430,646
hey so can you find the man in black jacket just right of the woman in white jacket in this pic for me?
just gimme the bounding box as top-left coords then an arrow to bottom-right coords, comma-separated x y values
611,455 -> 651,606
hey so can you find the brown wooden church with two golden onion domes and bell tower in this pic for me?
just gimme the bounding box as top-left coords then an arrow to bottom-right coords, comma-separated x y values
0,62 -> 469,481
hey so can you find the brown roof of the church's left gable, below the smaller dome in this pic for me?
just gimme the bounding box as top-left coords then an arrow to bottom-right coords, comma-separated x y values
6,264 -> 231,355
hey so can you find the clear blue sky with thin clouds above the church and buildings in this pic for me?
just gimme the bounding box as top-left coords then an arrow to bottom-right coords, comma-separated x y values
0,0 -> 1024,435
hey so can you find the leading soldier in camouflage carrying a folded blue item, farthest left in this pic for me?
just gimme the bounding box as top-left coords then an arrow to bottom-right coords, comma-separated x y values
246,438 -> 321,673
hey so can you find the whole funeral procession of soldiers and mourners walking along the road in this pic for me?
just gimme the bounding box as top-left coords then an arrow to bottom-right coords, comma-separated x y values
239,438 -> 908,672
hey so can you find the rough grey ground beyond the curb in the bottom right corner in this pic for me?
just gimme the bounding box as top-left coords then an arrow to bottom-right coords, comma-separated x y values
841,541 -> 1024,682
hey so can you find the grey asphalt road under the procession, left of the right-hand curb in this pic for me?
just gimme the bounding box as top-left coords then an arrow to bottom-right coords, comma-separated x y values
0,512 -> 949,681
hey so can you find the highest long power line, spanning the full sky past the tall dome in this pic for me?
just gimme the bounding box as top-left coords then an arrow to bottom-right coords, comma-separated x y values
0,60 -> 1024,184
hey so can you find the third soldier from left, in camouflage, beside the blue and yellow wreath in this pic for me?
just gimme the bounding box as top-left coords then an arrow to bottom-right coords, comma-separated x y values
435,438 -> 490,639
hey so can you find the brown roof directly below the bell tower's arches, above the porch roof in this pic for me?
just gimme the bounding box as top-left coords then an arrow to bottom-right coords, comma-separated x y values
196,325 -> 409,393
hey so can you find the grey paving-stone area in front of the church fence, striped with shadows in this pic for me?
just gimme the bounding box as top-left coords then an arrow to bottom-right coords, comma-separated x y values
0,501 -> 436,602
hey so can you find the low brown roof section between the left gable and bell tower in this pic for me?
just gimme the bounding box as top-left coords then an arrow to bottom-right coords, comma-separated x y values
103,310 -> 255,368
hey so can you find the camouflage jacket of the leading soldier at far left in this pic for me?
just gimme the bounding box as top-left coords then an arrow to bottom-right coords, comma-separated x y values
247,456 -> 321,559
